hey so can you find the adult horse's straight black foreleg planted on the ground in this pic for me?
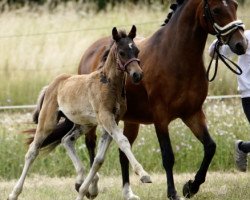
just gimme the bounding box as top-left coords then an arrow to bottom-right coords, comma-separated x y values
154,123 -> 180,200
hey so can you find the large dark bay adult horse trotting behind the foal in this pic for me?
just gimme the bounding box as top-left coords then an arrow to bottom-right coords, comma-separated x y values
78,0 -> 248,200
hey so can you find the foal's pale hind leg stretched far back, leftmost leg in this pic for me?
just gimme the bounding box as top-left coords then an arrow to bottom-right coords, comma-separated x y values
8,103 -> 58,200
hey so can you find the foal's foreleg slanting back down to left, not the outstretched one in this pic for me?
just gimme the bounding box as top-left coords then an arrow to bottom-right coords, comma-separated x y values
77,131 -> 112,200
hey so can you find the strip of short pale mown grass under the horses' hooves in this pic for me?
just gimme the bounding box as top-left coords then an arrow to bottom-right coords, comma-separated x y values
0,172 -> 250,200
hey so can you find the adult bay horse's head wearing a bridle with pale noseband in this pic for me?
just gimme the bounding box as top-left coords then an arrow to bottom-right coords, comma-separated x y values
202,0 -> 248,55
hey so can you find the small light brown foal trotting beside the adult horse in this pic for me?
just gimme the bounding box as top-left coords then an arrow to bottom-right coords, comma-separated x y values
8,26 -> 151,200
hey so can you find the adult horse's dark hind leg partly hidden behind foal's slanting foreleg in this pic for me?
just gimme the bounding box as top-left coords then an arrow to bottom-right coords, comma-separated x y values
85,126 -> 99,199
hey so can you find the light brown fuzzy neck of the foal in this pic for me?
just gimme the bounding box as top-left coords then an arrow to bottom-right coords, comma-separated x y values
103,45 -> 125,83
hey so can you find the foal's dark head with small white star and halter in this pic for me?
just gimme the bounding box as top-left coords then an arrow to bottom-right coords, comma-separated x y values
112,25 -> 143,83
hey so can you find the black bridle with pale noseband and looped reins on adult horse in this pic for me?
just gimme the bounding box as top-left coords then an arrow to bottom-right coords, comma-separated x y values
204,0 -> 245,82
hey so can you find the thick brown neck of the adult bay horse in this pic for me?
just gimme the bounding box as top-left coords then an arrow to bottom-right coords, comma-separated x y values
152,0 -> 208,59
